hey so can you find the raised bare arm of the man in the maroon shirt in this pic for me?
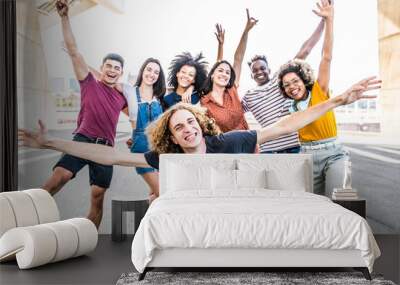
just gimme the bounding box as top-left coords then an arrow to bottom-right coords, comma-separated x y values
56,0 -> 89,80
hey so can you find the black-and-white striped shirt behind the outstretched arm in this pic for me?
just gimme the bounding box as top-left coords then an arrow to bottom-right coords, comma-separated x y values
242,76 -> 300,152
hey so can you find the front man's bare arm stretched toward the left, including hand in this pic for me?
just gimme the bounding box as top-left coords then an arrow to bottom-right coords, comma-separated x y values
18,121 -> 149,167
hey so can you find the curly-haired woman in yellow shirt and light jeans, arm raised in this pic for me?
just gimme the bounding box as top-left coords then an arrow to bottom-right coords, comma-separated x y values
279,0 -> 348,196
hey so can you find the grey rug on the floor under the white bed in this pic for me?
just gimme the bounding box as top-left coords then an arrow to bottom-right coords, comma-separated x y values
116,271 -> 395,285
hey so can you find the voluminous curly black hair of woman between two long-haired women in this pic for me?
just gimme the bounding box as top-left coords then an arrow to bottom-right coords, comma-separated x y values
168,52 -> 208,92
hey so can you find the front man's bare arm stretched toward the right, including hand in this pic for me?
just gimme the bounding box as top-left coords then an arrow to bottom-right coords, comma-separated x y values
257,76 -> 381,144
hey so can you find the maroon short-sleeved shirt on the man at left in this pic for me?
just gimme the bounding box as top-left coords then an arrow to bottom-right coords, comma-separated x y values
74,72 -> 127,145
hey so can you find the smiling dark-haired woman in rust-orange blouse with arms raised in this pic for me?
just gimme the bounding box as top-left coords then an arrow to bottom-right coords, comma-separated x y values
200,10 -> 258,132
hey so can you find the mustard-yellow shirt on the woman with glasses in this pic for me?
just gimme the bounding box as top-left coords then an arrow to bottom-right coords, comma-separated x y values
299,81 -> 337,142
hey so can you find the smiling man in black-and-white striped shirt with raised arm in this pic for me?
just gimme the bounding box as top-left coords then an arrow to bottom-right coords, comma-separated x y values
242,20 -> 324,153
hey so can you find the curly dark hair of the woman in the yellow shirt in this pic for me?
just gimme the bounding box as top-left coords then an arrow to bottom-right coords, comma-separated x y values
278,59 -> 315,98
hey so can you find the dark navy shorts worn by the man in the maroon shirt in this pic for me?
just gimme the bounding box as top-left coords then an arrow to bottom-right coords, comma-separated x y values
53,134 -> 113,189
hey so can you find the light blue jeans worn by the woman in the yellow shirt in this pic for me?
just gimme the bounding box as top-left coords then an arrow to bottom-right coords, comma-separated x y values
301,139 -> 349,197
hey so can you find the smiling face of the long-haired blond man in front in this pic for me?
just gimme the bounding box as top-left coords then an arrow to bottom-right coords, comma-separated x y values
169,109 -> 203,152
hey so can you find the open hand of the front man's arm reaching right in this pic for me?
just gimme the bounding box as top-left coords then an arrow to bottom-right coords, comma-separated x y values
338,76 -> 382,105
